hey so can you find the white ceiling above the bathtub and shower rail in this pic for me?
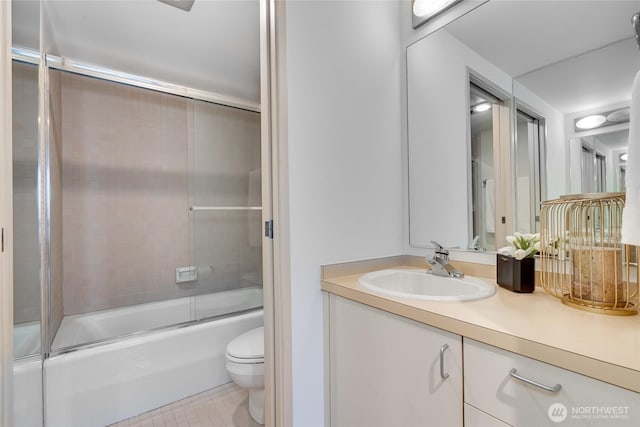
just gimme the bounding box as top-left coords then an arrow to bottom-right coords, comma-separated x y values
14,0 -> 260,102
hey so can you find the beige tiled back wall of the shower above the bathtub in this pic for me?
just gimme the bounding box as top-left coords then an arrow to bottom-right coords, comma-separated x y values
54,71 -> 261,315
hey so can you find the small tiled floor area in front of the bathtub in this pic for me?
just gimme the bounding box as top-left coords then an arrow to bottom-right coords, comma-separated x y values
111,383 -> 261,427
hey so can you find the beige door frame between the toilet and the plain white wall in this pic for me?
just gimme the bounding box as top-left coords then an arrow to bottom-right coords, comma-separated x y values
260,0 -> 293,427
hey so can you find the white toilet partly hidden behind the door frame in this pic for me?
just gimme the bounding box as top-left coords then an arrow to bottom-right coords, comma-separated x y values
225,326 -> 264,424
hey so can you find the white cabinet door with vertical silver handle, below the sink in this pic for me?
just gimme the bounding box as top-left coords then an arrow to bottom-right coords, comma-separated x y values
327,295 -> 462,427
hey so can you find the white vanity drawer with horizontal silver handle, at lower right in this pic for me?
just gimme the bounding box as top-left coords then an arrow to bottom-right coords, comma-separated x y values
464,339 -> 640,427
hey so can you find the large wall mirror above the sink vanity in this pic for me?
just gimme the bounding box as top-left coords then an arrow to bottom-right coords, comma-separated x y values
407,0 -> 640,251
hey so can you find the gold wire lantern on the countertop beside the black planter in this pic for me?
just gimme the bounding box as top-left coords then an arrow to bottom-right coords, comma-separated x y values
540,193 -> 640,315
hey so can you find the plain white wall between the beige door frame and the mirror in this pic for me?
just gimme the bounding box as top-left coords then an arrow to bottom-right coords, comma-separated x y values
286,1 -> 402,427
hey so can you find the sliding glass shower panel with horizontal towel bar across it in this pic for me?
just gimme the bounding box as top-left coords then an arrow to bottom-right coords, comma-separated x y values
190,101 -> 262,319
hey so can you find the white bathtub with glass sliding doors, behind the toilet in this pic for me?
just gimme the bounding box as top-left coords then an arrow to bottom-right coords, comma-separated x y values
44,288 -> 263,427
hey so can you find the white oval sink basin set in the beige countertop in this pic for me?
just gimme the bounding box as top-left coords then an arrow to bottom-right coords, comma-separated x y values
359,270 -> 496,301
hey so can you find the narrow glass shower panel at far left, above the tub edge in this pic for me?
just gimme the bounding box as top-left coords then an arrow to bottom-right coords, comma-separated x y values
12,2 -> 41,358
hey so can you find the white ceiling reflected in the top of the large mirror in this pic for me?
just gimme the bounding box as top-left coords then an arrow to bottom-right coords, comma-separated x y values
447,0 -> 640,113
